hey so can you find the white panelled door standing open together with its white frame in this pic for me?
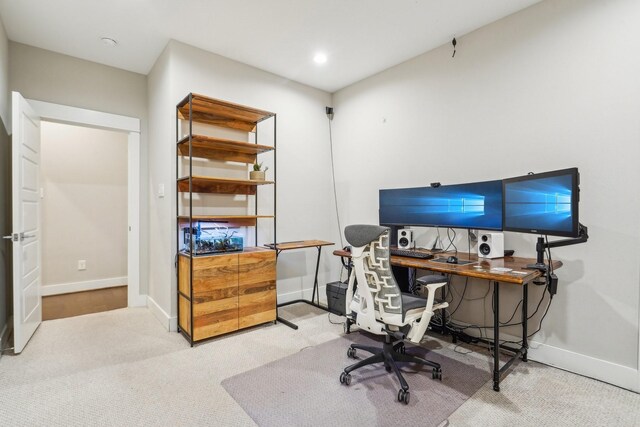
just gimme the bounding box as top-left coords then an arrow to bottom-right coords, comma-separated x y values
8,92 -> 147,354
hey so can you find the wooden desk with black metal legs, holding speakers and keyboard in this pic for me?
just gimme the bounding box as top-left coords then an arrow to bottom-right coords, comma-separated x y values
333,250 -> 562,391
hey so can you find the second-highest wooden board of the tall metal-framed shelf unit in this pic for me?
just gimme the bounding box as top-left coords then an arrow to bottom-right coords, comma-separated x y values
178,135 -> 273,163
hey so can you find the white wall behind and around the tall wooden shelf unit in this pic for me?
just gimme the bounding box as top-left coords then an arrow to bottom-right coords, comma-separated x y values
148,42 -> 339,328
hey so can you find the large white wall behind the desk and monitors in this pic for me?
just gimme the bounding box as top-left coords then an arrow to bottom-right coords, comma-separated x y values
334,0 -> 640,389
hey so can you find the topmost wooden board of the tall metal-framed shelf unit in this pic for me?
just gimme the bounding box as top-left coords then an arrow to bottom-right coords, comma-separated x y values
177,93 -> 275,132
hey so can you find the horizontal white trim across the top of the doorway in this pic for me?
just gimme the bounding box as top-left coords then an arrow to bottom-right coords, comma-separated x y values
28,99 -> 140,132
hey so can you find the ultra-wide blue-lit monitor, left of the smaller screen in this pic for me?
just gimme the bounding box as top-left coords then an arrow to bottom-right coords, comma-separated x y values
379,180 -> 502,230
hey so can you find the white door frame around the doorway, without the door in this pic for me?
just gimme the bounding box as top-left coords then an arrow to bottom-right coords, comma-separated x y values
27,99 -> 147,307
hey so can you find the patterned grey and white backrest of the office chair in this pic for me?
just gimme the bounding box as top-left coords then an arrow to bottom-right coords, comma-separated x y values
364,230 -> 402,314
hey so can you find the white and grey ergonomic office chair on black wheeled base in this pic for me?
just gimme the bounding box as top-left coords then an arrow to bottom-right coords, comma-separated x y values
340,225 -> 448,404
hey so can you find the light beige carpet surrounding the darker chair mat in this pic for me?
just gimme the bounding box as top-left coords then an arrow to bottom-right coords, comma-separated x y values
0,304 -> 640,426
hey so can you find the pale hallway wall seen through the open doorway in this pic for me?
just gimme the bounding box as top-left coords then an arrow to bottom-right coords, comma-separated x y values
41,122 -> 128,294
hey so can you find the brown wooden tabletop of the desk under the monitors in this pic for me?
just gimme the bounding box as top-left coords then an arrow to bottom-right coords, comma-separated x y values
333,249 -> 562,285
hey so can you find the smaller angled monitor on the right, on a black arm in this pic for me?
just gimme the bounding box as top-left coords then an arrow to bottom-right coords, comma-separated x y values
503,168 -> 579,237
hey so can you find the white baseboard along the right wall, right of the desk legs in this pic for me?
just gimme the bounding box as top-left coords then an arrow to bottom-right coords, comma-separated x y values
528,341 -> 640,392
